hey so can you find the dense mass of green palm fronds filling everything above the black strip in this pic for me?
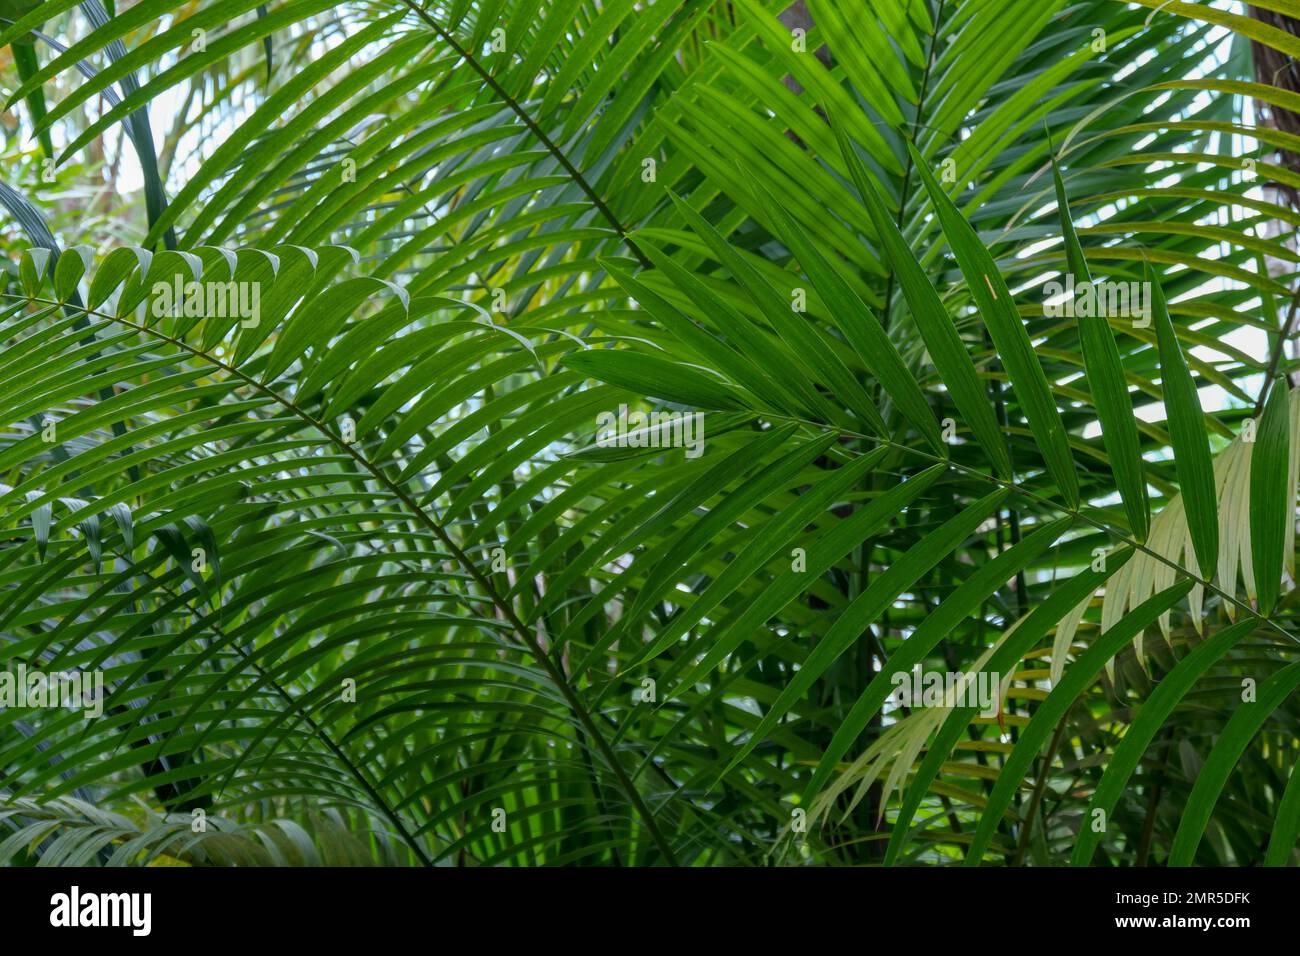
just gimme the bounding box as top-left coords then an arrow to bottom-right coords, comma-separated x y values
0,0 -> 1300,865
